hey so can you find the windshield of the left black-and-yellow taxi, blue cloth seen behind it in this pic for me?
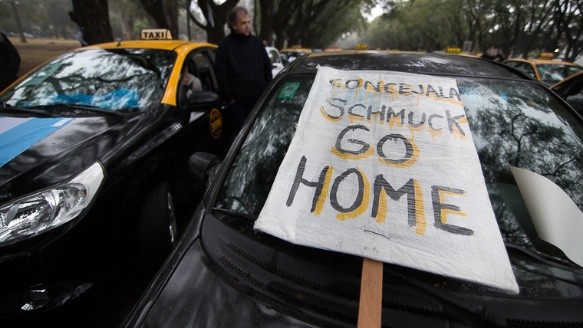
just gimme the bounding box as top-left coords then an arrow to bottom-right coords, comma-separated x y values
0,49 -> 175,111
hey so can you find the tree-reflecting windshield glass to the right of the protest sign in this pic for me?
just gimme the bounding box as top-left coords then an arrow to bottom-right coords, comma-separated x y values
460,82 -> 583,210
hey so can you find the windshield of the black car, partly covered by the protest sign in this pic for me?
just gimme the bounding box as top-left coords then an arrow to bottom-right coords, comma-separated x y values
213,74 -> 583,324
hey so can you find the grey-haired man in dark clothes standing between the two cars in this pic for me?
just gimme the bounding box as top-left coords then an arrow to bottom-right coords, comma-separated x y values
215,7 -> 272,133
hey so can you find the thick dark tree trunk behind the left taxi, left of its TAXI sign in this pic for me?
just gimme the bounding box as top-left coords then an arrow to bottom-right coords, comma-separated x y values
69,0 -> 113,44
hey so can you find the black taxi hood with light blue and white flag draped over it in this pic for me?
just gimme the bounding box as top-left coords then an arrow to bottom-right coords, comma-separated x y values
0,116 -> 140,203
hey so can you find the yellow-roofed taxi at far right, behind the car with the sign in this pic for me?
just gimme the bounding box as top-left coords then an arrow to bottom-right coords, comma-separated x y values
502,53 -> 583,86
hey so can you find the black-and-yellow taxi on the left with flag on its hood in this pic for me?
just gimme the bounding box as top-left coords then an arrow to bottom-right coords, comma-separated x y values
0,40 -> 230,318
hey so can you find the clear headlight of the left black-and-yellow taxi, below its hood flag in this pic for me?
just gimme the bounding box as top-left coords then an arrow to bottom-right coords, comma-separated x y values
0,162 -> 105,246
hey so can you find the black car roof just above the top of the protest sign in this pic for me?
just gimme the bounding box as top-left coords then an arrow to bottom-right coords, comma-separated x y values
289,50 -> 529,80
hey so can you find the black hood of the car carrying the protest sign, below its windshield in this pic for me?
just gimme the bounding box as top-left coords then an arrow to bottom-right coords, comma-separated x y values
133,239 -> 315,328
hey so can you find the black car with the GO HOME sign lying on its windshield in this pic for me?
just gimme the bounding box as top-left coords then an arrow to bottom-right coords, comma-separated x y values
125,51 -> 583,327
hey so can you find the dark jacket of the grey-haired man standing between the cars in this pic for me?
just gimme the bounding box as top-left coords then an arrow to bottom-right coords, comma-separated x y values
215,33 -> 272,106
